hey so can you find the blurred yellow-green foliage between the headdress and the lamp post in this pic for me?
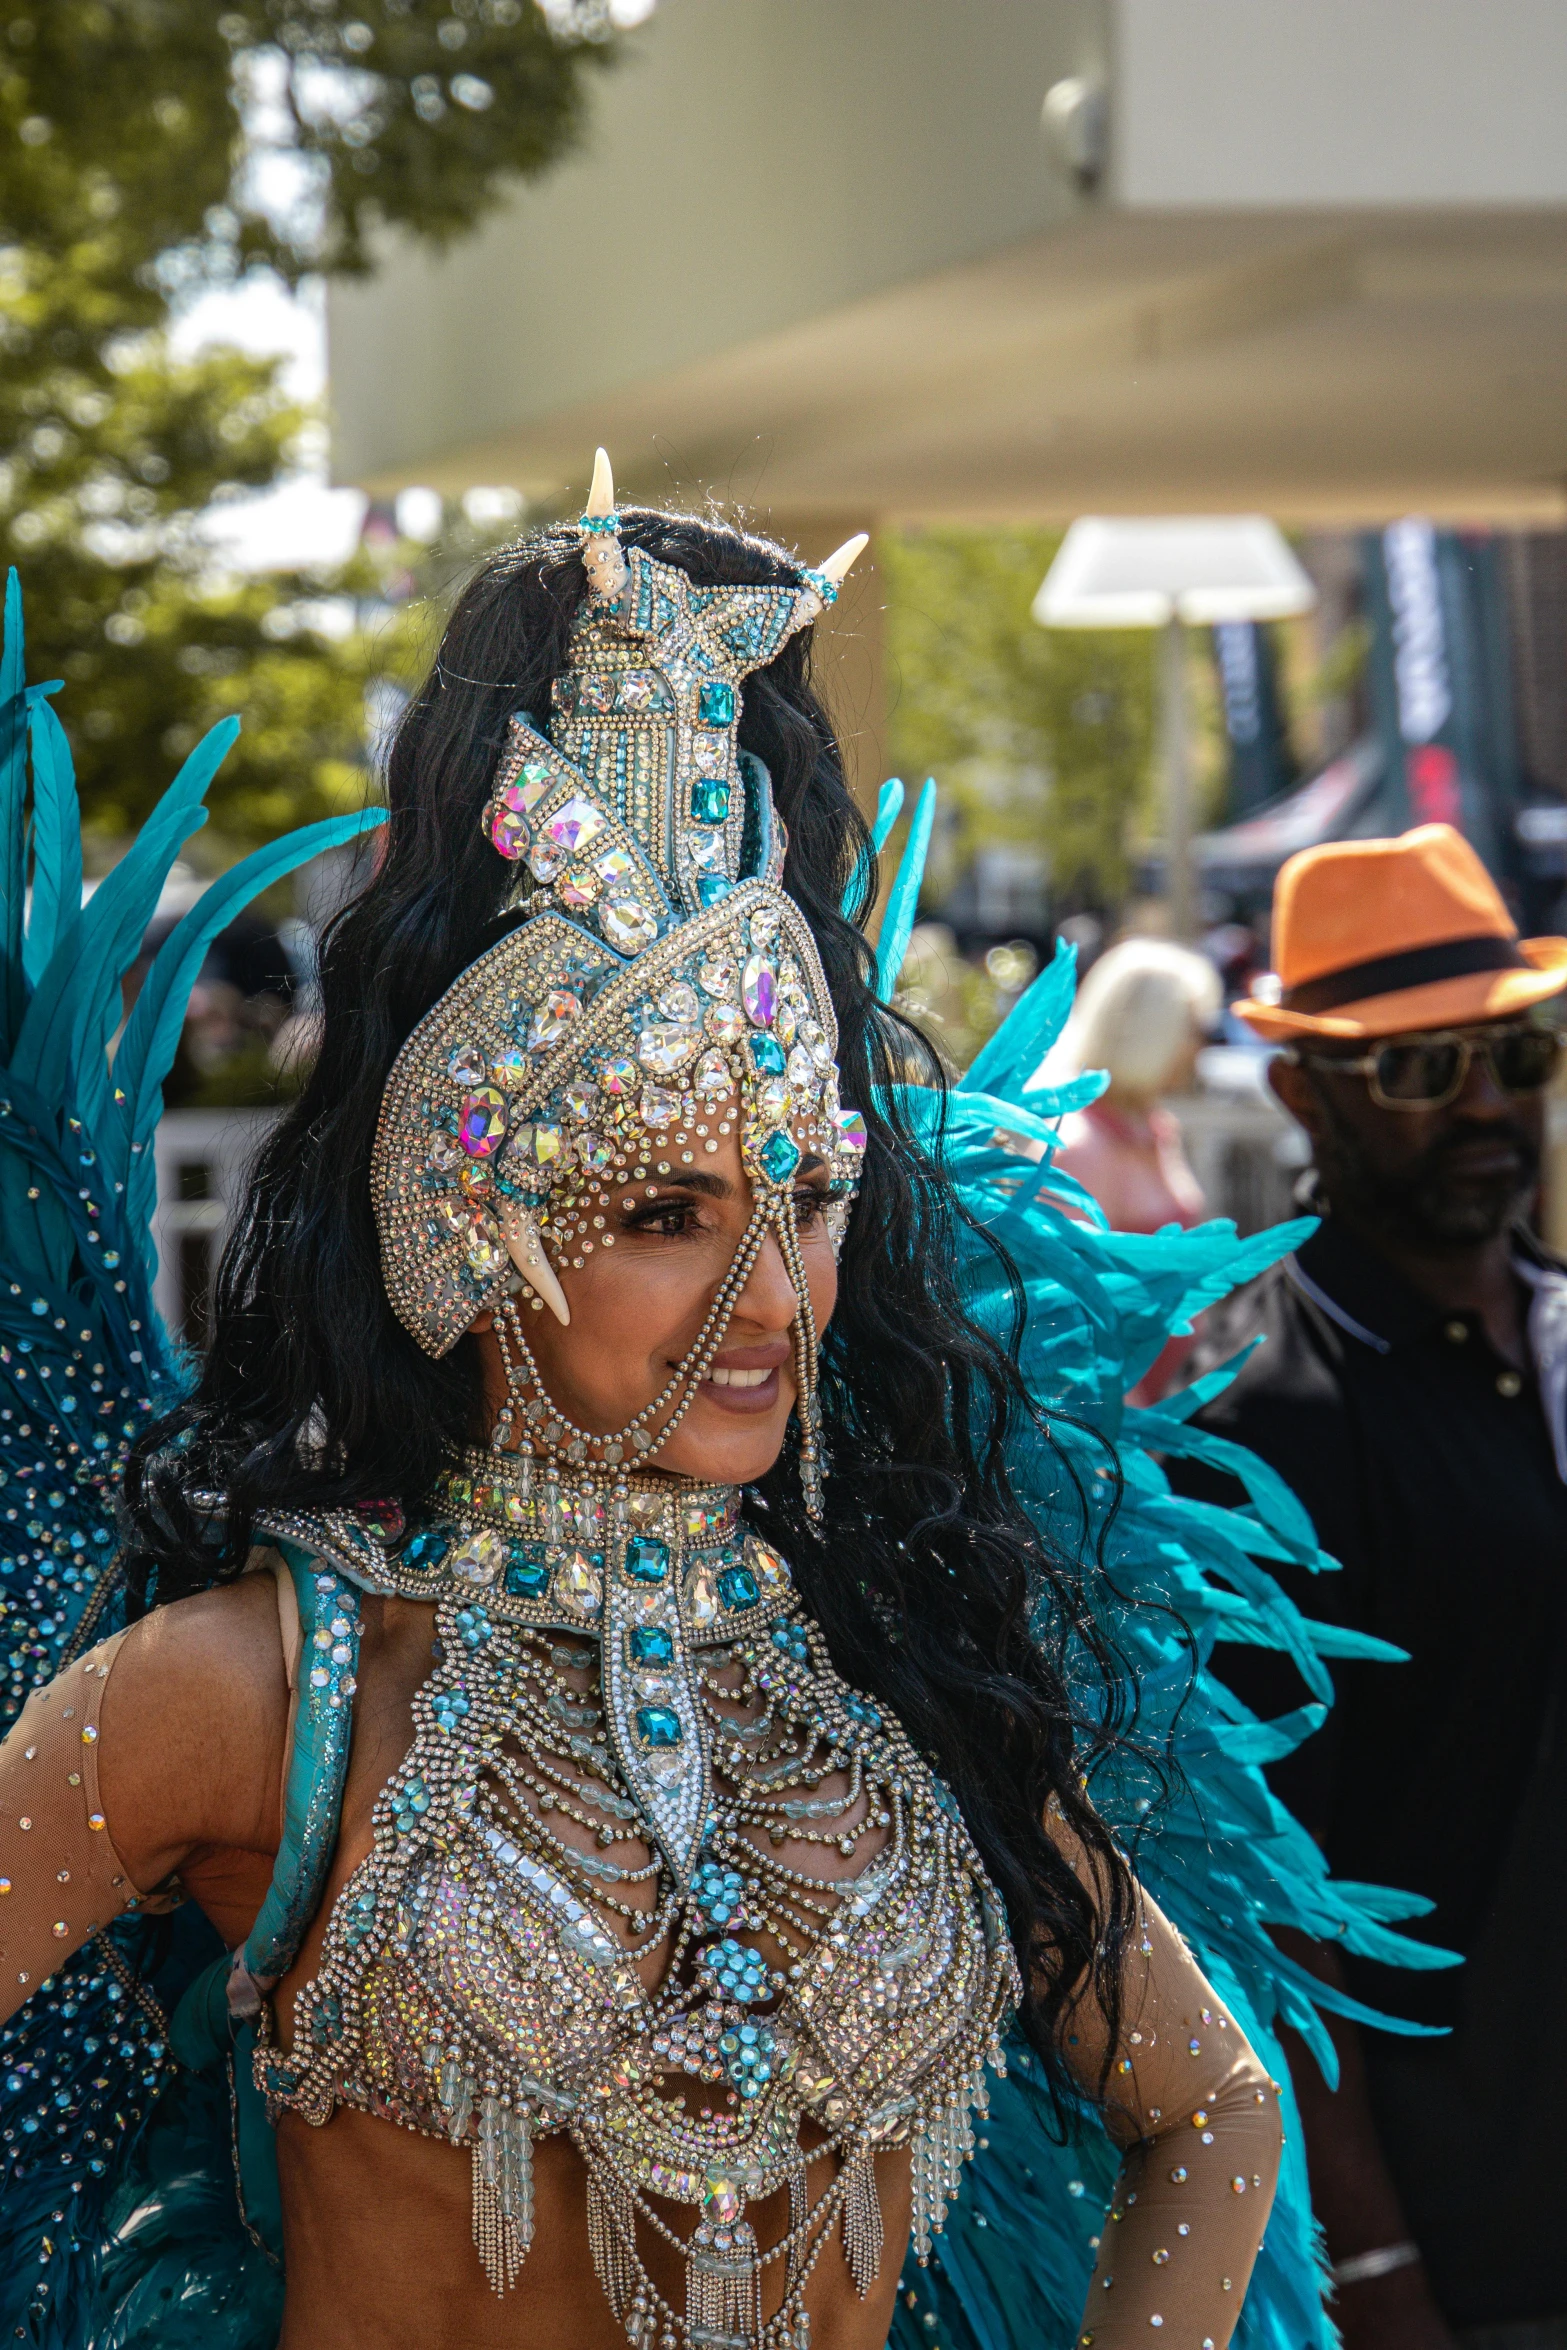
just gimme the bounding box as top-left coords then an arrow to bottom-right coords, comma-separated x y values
876,529 -> 1154,905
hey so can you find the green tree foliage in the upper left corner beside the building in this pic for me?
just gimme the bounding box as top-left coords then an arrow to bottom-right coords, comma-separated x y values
0,0 -> 613,841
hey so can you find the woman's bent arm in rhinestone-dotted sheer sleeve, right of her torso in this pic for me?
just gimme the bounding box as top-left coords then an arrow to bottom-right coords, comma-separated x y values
1050,1819 -> 1283,2350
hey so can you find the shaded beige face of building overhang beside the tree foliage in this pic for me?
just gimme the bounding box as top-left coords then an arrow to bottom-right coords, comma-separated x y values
329,0 -> 1107,486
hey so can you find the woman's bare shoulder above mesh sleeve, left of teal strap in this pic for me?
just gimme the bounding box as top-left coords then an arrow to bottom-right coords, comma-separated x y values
99,1572 -> 289,1885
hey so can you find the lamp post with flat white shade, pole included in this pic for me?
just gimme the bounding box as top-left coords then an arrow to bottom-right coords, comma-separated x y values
1034,515 -> 1316,938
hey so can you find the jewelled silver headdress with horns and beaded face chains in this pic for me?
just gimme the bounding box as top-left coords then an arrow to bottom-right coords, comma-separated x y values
371,451 -> 865,1511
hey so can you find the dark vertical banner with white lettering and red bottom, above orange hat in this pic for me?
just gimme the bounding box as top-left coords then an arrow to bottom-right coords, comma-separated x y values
1363,519 -> 1518,874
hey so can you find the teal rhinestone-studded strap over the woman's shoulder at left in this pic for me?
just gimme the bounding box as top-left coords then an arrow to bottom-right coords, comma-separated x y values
169,1542 -> 359,2258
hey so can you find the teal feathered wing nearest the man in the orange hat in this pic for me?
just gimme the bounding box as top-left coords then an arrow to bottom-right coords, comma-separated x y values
881,822 -> 1454,2350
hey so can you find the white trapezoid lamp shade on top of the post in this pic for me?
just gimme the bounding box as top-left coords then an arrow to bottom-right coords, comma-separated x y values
1034,515 -> 1316,627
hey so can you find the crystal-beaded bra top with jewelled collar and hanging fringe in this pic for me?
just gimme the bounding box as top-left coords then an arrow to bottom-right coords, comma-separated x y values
256,1455 -> 1017,2343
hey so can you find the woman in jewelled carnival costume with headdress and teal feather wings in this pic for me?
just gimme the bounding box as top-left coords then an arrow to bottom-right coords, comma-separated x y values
0,458 -> 1414,2350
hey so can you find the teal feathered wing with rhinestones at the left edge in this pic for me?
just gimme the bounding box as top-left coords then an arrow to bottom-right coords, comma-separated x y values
0,573 -> 381,2350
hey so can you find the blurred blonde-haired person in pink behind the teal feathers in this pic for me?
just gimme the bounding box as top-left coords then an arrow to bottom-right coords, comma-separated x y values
1048,938 -> 1219,1403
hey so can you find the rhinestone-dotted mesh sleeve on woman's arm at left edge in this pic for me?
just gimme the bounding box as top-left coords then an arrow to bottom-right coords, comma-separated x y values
0,1633 -> 139,2021
